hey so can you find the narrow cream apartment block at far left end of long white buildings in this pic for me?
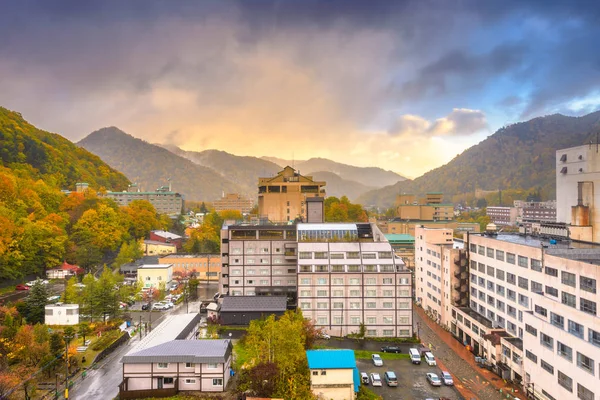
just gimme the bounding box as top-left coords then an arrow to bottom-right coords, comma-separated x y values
415,227 -> 468,328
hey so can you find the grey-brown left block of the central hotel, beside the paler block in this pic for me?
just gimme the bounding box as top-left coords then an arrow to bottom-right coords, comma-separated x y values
219,225 -> 298,305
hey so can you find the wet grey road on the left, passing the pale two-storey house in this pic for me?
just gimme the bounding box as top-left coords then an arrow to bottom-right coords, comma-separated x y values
69,301 -> 200,400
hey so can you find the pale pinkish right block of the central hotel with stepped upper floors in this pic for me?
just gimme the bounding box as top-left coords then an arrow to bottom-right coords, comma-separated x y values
298,223 -> 412,337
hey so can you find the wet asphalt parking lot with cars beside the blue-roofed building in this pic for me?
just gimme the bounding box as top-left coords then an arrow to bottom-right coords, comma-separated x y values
356,359 -> 462,400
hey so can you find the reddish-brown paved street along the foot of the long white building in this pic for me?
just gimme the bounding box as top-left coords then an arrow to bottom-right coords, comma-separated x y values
413,305 -> 526,400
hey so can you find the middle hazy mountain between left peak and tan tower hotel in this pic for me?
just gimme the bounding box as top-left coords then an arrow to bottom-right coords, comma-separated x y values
163,145 -> 281,199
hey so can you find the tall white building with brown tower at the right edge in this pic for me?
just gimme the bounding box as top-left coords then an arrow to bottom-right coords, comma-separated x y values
556,144 -> 600,243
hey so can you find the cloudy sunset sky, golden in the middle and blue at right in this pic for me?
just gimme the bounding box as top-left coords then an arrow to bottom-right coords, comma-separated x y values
0,0 -> 600,177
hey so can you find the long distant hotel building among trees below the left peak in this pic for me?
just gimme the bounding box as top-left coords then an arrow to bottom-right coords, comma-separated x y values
100,184 -> 183,215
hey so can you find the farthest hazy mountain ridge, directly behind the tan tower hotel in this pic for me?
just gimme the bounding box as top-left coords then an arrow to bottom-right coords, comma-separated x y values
262,157 -> 406,187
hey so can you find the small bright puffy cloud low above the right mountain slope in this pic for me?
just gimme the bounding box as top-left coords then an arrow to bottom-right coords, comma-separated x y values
388,108 -> 487,137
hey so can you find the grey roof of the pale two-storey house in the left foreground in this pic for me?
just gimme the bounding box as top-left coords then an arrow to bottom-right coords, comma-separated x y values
121,339 -> 231,364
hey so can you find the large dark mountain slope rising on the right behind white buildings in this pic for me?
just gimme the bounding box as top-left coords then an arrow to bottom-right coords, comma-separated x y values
357,111 -> 600,206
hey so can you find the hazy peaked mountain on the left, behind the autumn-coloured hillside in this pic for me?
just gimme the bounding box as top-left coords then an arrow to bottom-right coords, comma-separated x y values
77,127 -> 243,201
